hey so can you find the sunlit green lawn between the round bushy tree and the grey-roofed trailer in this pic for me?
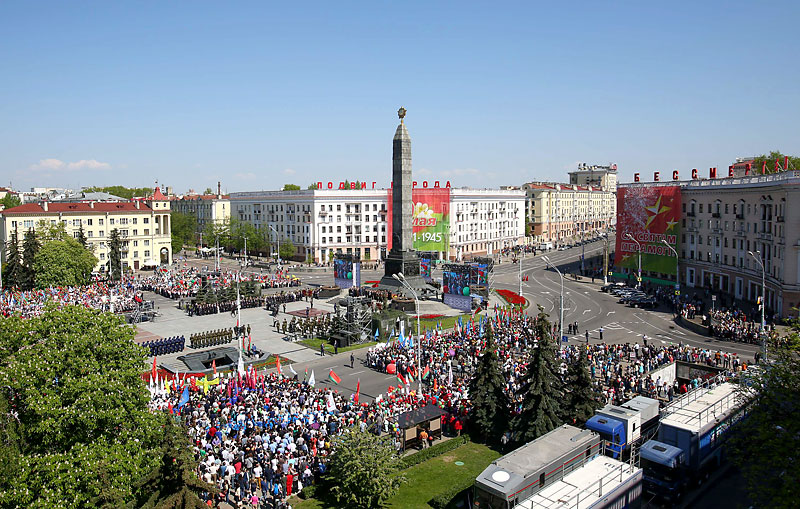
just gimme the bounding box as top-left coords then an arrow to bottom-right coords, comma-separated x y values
291,442 -> 500,509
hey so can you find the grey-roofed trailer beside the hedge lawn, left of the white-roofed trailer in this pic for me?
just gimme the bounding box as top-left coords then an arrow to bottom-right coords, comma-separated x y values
473,424 -> 601,509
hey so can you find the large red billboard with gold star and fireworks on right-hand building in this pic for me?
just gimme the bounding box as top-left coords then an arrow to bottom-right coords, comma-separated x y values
614,186 -> 681,275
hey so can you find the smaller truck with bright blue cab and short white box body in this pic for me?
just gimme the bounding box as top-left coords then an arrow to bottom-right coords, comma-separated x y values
586,396 -> 659,458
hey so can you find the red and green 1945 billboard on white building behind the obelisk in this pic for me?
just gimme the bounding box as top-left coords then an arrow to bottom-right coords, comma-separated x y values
386,188 -> 450,253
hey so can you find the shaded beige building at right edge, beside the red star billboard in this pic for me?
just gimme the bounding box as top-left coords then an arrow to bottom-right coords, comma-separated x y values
625,171 -> 800,316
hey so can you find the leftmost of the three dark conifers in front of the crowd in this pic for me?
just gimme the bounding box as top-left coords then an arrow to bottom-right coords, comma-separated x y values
469,325 -> 511,443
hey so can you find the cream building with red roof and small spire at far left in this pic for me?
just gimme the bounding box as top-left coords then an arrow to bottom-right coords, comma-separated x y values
0,188 -> 172,270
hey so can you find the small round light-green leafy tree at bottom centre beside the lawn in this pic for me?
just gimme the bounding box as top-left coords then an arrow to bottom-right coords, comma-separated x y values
328,428 -> 405,508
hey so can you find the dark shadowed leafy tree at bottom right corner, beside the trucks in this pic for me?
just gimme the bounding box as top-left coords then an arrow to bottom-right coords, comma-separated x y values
729,344 -> 800,508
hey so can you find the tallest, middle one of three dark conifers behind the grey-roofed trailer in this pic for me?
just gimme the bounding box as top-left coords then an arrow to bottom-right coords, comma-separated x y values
512,312 -> 561,443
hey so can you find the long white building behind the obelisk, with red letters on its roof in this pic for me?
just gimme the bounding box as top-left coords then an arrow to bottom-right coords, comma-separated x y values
230,188 -> 525,262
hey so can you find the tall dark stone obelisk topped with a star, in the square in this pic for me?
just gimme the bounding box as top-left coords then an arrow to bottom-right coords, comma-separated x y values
379,108 -> 429,292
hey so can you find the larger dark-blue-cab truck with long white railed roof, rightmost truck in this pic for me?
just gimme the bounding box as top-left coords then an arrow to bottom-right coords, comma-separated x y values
639,379 -> 749,503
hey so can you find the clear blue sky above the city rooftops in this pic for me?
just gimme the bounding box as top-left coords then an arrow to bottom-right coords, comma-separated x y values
0,0 -> 800,192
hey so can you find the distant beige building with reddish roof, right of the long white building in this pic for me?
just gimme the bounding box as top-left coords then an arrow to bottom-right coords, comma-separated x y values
522,180 -> 617,247
